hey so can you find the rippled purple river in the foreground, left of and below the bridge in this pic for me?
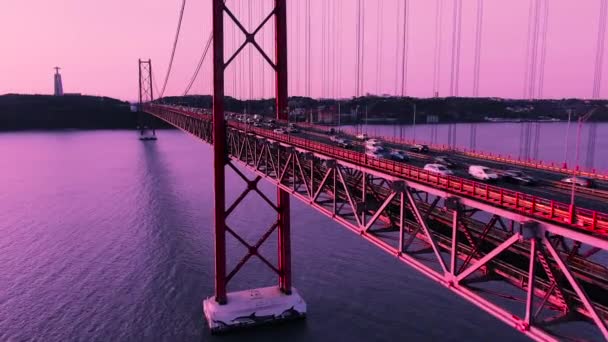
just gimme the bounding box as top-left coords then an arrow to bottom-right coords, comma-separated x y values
0,130 -> 548,342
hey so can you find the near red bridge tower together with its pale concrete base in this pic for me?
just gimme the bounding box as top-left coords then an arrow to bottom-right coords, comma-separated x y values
203,0 -> 306,333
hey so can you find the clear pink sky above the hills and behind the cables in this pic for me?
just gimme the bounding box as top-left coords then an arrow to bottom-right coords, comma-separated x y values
0,0 -> 608,100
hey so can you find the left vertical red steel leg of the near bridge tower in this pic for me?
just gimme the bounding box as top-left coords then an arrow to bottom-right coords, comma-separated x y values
212,0 -> 227,304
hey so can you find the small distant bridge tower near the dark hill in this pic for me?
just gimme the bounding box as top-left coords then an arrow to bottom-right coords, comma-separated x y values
137,59 -> 156,140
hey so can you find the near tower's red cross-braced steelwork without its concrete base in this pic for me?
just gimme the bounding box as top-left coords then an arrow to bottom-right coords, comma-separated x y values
208,0 -> 292,305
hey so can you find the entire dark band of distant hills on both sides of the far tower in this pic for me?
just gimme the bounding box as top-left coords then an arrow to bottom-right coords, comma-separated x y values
0,94 -> 608,131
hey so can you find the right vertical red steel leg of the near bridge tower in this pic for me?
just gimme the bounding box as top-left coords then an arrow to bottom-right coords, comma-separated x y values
274,0 -> 291,294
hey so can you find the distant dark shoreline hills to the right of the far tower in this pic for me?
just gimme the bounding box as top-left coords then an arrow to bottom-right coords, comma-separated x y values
162,95 -> 608,124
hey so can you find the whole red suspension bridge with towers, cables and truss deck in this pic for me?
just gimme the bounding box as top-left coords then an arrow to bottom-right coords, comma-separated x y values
139,0 -> 608,341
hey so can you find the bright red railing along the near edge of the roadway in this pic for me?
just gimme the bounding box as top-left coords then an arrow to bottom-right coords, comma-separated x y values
146,107 -> 608,235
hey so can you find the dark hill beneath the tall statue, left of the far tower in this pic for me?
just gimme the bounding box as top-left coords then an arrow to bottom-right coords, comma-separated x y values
0,94 -> 142,131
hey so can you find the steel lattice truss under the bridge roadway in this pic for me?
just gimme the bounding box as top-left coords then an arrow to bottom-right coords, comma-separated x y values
146,105 -> 608,341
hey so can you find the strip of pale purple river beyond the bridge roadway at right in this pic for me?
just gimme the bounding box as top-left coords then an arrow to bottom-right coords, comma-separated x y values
346,122 -> 608,173
